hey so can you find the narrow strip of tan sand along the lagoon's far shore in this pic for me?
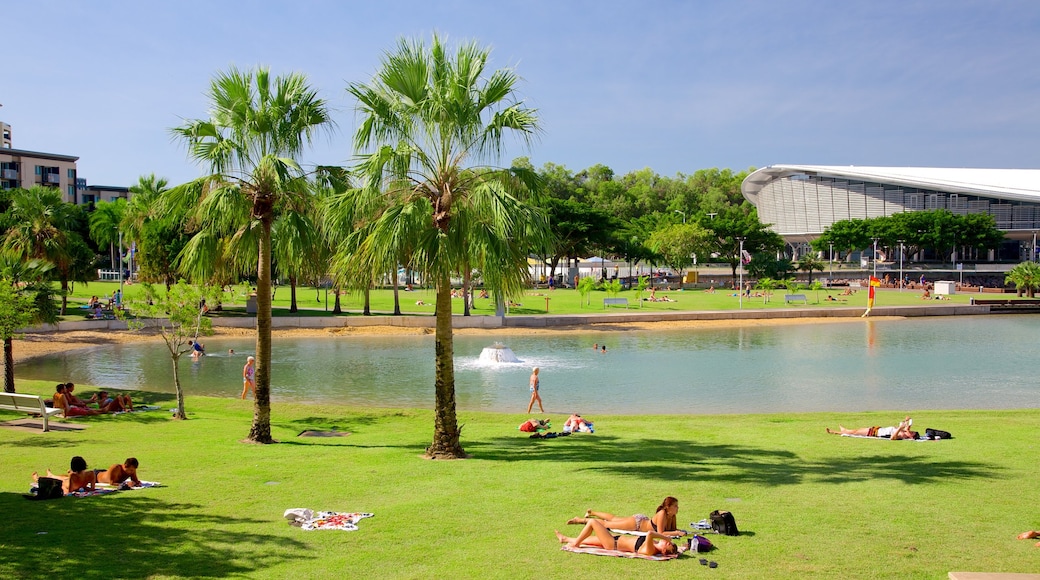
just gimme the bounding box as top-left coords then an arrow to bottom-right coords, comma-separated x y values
6,317 -> 895,363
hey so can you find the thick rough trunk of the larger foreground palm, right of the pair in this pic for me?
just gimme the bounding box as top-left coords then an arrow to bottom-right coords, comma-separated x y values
426,275 -> 466,459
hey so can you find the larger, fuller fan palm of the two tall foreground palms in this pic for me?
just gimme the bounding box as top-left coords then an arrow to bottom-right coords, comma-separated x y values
347,35 -> 548,458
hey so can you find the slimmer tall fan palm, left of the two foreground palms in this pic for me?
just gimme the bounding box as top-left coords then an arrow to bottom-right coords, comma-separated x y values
165,68 -> 333,443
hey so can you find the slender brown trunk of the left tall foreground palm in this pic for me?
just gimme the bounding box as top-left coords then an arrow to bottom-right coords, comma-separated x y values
248,219 -> 275,443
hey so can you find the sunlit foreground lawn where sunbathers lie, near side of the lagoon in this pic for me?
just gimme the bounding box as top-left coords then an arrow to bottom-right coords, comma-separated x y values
0,380 -> 1040,578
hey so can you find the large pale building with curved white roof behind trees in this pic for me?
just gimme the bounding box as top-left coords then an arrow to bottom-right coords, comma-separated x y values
742,165 -> 1040,259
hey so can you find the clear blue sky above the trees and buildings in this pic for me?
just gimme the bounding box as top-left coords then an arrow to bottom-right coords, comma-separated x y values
0,0 -> 1040,186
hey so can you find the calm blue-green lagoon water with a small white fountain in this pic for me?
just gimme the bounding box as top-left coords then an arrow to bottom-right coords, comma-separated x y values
15,315 -> 1040,415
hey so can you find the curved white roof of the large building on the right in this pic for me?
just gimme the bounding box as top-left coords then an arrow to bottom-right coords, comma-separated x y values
740,165 -> 1040,203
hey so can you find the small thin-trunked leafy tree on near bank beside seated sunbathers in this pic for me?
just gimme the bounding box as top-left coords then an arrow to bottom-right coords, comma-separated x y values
127,281 -> 220,419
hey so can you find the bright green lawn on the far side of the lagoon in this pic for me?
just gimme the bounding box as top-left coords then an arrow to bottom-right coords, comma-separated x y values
66,282 -> 973,320
